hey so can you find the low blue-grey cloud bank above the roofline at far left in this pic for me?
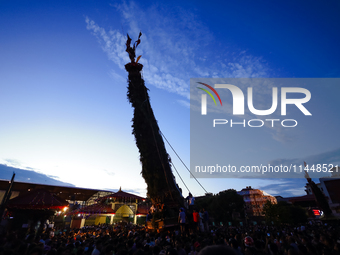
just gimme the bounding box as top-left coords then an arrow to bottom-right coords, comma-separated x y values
0,164 -> 75,187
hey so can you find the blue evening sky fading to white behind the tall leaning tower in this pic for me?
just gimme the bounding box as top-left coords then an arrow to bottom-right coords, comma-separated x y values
0,1 -> 340,195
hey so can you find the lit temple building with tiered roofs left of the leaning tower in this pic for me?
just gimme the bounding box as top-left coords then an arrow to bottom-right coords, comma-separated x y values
0,180 -> 151,228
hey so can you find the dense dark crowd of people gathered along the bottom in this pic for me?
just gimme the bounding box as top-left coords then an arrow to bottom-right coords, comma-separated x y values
0,217 -> 340,255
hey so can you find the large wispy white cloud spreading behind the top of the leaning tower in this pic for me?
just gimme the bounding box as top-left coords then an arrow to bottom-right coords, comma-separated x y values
85,2 -> 268,100
